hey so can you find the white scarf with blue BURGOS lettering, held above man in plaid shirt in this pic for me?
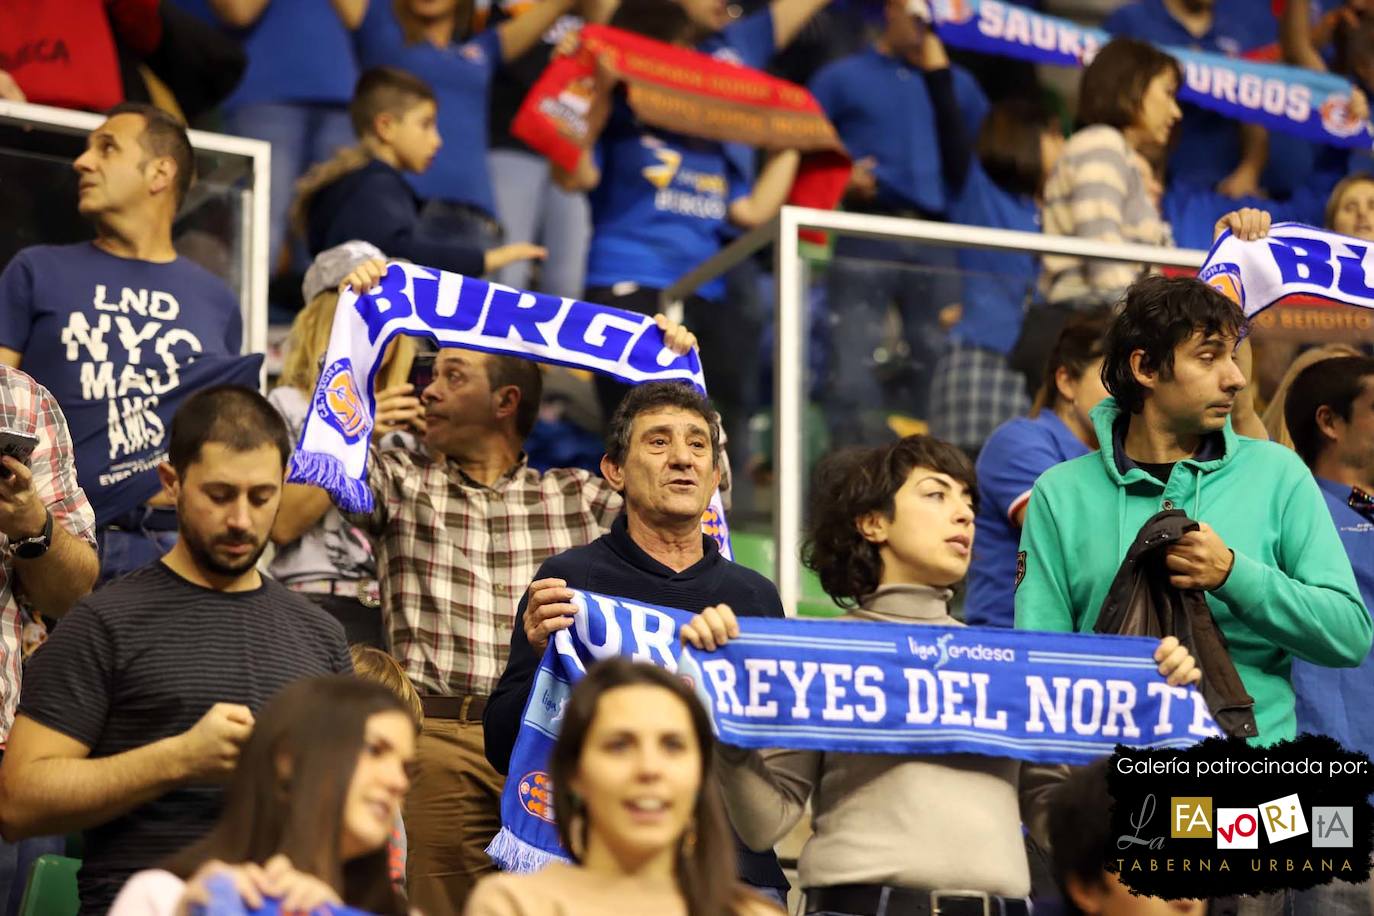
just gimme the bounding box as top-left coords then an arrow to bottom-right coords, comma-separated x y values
287,261 -> 731,559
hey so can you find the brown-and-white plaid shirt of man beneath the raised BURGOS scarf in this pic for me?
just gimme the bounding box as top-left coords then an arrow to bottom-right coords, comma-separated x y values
353,449 -> 621,696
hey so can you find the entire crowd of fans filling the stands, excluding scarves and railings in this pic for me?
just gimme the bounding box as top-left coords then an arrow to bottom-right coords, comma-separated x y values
0,0 -> 1374,916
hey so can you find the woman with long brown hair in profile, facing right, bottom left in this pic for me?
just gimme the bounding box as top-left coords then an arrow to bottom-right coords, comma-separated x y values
110,674 -> 416,916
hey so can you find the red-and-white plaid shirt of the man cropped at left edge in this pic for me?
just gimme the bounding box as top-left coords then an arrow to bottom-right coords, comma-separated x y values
0,365 -> 95,739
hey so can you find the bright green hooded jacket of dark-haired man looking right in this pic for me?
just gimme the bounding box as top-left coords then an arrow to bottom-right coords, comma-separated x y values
1015,397 -> 1374,744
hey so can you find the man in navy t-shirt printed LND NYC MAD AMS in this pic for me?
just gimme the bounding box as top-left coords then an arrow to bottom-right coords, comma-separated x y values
0,104 -> 257,580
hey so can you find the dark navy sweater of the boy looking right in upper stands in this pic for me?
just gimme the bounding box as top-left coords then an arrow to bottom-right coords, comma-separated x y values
306,159 -> 485,276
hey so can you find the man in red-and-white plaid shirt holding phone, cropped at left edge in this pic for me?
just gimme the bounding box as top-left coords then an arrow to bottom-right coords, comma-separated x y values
0,365 -> 99,906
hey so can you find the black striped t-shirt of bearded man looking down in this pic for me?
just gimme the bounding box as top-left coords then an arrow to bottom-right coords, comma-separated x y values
19,562 -> 353,913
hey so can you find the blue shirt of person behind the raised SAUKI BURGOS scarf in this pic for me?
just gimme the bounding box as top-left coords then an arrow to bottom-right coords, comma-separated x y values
1102,0 -> 1276,188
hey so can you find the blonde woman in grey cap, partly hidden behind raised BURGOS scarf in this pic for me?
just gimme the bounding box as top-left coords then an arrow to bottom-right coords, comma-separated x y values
268,242 -> 425,648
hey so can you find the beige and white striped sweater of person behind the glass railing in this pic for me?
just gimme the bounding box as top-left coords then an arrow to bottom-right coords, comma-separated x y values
1040,124 -> 1173,302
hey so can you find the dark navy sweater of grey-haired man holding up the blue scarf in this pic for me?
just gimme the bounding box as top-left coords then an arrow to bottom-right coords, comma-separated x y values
482,515 -> 787,889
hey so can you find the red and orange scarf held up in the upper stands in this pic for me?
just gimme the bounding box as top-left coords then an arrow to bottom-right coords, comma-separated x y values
511,25 -> 849,210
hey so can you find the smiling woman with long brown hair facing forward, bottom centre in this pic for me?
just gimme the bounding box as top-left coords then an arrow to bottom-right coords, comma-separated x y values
466,658 -> 779,916
